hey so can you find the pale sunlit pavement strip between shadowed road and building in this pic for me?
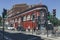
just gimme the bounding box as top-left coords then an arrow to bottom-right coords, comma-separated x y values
5,30 -> 60,40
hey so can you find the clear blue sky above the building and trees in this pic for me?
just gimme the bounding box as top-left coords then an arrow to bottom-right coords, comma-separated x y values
0,0 -> 60,19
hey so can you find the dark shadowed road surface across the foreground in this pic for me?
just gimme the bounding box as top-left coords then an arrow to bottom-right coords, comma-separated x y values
0,31 -> 43,40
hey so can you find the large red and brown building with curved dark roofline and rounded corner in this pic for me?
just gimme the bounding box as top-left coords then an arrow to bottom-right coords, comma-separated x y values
7,4 -> 48,29
